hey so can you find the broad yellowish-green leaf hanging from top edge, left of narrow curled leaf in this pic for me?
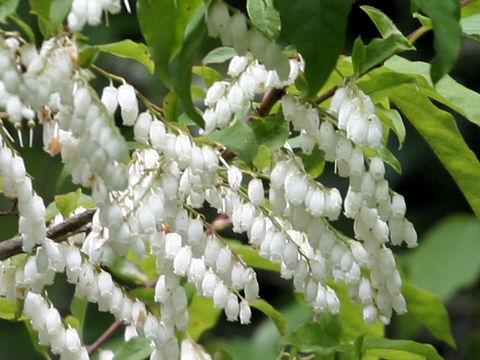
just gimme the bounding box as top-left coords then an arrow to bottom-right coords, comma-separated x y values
137,0 -> 203,86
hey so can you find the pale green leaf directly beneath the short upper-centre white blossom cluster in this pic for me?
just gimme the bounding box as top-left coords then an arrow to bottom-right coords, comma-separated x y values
209,121 -> 258,163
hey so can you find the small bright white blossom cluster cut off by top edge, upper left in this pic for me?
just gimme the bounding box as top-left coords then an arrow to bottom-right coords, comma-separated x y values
67,0 -> 131,31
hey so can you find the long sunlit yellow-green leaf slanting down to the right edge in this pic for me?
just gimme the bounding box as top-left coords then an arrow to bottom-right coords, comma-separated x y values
391,85 -> 480,218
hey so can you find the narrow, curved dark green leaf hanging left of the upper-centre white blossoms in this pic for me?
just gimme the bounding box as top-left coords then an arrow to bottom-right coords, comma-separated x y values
169,5 -> 206,127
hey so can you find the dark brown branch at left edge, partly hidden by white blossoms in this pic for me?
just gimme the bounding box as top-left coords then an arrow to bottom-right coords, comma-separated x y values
0,208 -> 97,260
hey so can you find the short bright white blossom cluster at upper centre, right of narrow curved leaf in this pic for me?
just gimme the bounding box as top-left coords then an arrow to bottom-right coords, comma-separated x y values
203,56 -> 303,134
